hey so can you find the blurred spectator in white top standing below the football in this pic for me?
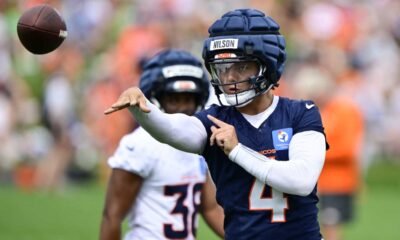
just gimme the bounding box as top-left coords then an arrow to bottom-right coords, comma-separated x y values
37,48 -> 76,190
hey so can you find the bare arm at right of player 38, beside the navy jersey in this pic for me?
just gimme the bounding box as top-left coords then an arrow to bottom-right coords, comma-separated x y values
200,174 -> 224,238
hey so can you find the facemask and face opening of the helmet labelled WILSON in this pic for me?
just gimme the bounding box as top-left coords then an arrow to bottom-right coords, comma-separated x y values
209,54 -> 272,107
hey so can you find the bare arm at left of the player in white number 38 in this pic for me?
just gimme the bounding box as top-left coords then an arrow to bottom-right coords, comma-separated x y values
100,168 -> 143,240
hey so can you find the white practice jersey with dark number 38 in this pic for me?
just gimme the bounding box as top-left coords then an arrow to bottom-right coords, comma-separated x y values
108,128 -> 207,240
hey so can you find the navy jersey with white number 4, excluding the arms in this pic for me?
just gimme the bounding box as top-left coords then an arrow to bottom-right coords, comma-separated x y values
196,97 -> 324,240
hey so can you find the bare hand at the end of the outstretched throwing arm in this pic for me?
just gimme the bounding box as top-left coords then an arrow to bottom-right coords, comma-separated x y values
104,87 -> 150,114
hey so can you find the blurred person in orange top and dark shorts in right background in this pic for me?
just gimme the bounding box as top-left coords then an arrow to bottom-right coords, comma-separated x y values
291,62 -> 364,240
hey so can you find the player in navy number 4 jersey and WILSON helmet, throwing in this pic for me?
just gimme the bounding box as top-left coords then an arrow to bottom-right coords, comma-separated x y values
105,9 -> 328,240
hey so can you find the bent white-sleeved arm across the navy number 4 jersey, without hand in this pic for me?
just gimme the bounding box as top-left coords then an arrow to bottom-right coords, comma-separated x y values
229,131 -> 326,196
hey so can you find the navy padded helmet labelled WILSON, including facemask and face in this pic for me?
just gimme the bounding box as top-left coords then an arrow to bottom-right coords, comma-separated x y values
203,9 -> 286,106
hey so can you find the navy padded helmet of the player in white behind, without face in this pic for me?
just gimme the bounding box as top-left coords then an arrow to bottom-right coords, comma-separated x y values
139,49 -> 210,110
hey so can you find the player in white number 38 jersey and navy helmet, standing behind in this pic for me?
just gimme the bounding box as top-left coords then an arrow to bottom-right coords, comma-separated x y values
100,50 -> 224,240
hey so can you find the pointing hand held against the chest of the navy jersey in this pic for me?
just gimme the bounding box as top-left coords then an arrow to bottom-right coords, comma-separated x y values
207,115 -> 239,155
